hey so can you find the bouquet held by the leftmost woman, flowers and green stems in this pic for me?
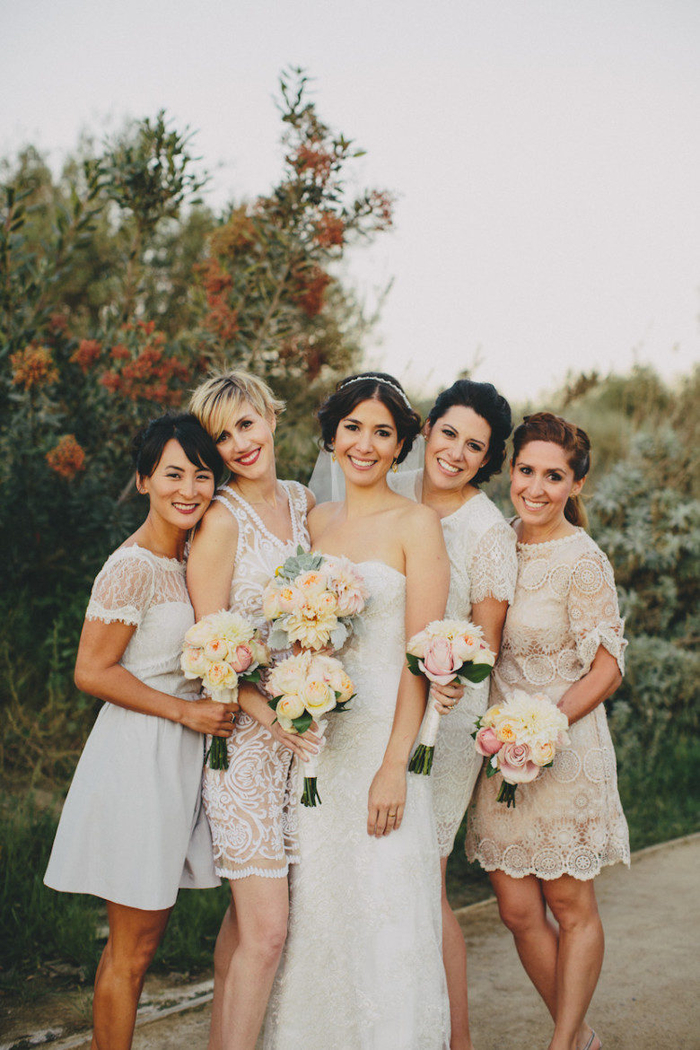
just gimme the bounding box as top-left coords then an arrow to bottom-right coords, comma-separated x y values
179,610 -> 270,770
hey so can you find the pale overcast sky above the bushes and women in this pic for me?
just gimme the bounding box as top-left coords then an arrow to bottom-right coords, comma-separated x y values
0,0 -> 700,400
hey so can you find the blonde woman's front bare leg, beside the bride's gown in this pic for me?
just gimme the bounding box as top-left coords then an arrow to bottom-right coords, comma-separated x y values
216,875 -> 290,1050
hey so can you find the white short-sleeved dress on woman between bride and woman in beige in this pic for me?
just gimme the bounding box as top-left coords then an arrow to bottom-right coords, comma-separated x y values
391,470 -> 517,857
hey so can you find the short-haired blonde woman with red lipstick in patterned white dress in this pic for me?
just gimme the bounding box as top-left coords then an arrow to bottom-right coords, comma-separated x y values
187,372 -> 314,1050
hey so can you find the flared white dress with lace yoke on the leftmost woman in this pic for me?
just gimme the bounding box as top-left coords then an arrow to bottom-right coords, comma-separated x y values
44,545 -> 219,910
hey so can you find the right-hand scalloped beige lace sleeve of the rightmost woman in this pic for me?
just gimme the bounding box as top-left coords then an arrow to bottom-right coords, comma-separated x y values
569,543 -> 627,674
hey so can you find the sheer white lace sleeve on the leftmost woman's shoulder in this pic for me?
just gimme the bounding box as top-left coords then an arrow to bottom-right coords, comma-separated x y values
85,547 -> 155,627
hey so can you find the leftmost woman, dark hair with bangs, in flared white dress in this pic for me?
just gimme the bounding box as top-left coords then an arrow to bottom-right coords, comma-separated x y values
44,415 -> 232,1050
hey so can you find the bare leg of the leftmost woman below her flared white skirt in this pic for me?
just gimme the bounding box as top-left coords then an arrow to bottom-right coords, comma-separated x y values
92,901 -> 172,1050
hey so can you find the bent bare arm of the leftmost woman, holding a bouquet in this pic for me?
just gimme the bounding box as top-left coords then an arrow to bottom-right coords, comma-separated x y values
76,620 -> 235,736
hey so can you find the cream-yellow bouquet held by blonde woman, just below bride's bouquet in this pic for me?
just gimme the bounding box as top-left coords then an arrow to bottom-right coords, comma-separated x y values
267,651 -> 355,805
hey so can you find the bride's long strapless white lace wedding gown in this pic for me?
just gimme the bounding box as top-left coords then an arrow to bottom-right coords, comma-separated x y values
264,562 -> 449,1050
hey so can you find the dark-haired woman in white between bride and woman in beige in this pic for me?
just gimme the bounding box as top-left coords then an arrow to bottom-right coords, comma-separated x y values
390,379 -> 517,1050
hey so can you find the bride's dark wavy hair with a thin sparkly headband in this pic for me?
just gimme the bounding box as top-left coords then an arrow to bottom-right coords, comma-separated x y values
316,372 -> 421,463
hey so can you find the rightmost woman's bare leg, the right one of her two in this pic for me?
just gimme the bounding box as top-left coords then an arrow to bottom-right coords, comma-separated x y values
543,875 -> 604,1050
